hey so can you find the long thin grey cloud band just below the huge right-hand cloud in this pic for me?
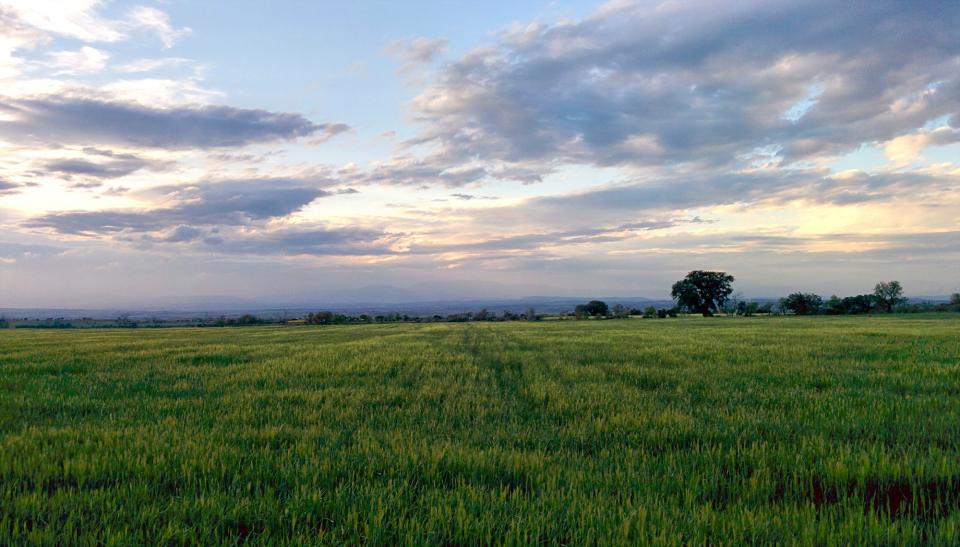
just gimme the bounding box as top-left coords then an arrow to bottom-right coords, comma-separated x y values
438,169 -> 960,237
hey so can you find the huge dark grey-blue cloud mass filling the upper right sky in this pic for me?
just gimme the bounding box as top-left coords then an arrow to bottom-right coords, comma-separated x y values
404,0 -> 960,176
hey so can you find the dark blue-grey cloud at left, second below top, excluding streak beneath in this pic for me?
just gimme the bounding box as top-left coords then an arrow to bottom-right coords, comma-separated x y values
26,179 -> 330,235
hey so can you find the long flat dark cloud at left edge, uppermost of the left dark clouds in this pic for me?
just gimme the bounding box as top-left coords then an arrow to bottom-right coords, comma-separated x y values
0,97 -> 349,149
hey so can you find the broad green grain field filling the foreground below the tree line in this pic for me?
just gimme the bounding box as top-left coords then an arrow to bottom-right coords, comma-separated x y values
0,314 -> 960,545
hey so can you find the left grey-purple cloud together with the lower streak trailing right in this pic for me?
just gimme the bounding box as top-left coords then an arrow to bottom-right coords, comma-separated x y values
24,179 -> 400,256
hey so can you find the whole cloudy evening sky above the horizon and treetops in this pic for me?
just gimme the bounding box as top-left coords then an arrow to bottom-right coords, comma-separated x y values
0,0 -> 960,307
